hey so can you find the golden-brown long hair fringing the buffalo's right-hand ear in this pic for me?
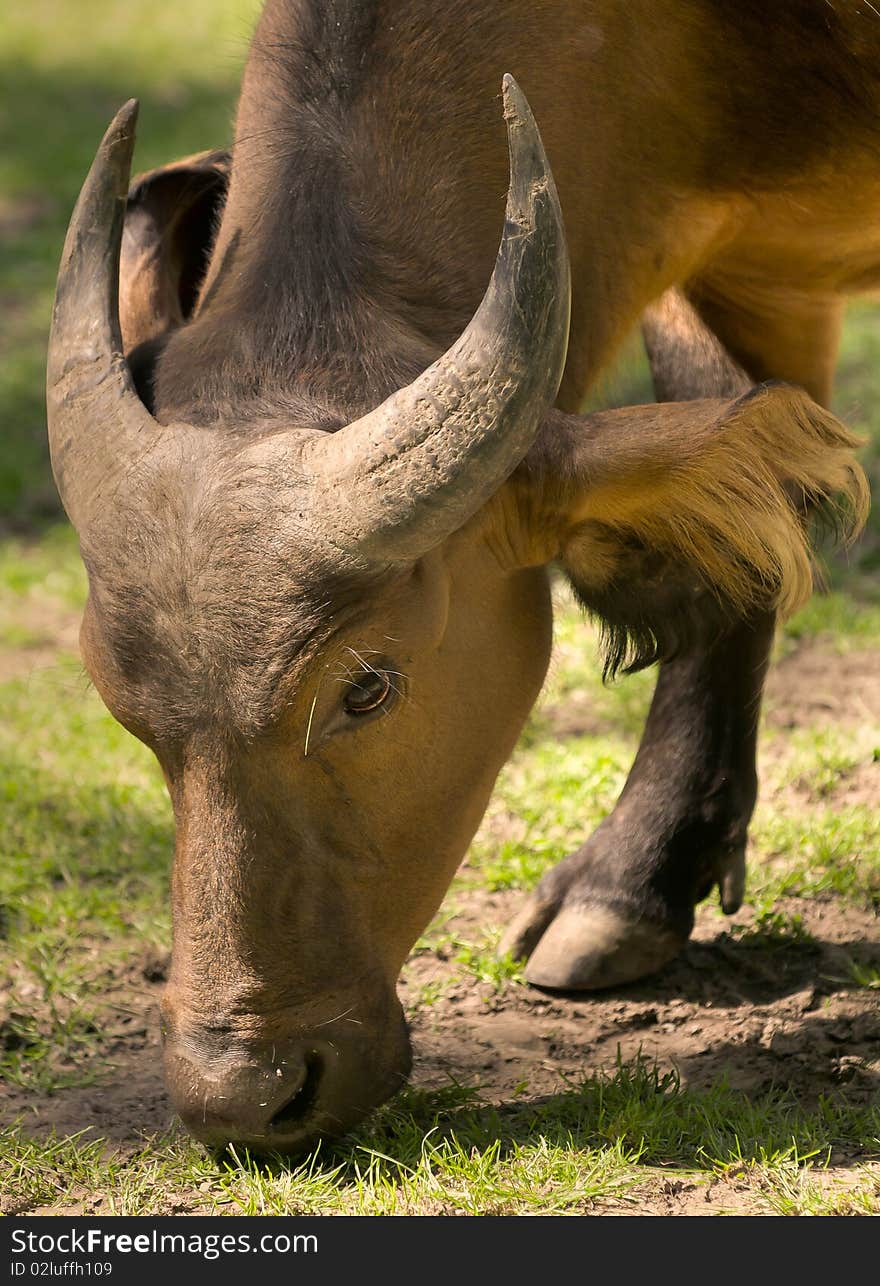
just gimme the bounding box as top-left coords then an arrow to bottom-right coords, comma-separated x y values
562,386 -> 868,616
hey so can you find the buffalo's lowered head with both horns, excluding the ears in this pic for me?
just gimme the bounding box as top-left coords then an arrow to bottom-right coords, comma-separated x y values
48,78 -> 569,1150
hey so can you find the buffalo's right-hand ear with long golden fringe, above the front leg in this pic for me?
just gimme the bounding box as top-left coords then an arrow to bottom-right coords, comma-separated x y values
508,383 -> 868,673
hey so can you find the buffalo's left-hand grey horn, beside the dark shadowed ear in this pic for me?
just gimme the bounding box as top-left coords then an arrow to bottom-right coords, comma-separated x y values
46,99 -> 158,531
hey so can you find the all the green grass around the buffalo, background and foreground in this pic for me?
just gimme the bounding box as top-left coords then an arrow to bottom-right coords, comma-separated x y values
0,0 -> 880,1214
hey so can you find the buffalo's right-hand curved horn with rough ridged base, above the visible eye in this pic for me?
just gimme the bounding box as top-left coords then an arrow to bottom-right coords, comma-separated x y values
306,76 -> 571,562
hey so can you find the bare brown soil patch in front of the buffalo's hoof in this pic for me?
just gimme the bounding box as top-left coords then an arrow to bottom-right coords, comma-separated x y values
401,894 -> 880,1102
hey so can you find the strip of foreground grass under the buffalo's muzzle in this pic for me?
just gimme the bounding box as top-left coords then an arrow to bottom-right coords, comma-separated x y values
0,1061 -> 880,1215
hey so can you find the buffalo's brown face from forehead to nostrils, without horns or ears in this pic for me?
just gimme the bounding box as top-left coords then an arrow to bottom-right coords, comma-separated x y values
82,449 -> 551,1150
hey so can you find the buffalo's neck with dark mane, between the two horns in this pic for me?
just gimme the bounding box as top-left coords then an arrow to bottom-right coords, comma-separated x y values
151,0 -> 506,419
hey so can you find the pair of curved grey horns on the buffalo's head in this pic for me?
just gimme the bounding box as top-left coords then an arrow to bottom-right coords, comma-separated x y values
46,76 -> 571,563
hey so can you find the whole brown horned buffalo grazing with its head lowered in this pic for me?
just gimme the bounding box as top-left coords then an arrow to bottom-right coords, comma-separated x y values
48,0 -> 880,1152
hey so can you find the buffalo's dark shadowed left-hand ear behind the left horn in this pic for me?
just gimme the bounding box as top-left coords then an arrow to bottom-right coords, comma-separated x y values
120,152 -> 230,404
